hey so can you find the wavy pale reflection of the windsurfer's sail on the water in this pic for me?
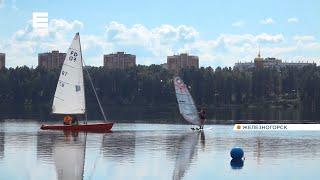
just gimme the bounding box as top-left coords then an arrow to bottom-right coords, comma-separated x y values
172,132 -> 205,180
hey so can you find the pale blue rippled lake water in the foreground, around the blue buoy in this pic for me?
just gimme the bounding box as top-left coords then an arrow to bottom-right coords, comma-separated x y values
0,120 -> 320,180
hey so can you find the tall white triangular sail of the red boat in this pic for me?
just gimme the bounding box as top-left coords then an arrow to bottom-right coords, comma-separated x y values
52,33 -> 86,114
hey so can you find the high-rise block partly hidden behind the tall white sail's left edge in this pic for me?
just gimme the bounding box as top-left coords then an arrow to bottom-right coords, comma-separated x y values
38,51 -> 67,69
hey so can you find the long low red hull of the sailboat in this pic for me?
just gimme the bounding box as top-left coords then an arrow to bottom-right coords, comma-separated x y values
40,122 -> 113,132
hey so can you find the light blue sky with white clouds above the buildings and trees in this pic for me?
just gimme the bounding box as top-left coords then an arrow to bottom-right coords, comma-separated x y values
0,0 -> 320,67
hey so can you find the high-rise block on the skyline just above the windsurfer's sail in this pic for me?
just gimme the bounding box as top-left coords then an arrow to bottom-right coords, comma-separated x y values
167,53 -> 199,71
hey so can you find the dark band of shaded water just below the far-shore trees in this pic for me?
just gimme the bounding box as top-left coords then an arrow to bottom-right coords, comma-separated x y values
0,104 -> 320,124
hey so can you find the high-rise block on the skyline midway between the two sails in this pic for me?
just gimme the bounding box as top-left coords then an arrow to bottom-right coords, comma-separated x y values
103,52 -> 136,69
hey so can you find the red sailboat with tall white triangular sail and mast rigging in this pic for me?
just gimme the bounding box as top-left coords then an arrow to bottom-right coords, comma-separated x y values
41,33 -> 113,132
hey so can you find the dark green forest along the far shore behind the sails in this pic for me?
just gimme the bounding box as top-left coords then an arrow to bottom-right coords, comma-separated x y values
0,65 -> 320,121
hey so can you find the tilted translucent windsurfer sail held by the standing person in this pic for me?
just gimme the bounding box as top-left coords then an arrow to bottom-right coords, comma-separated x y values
174,77 -> 201,125
